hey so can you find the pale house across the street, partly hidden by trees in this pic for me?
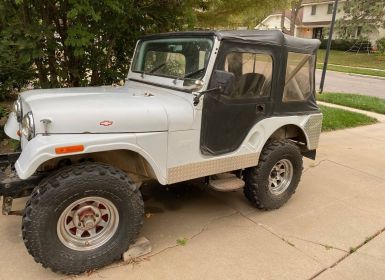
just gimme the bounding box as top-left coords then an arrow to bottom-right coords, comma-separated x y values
256,0 -> 385,43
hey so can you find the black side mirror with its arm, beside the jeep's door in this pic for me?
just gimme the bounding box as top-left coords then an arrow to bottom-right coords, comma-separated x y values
194,70 -> 235,106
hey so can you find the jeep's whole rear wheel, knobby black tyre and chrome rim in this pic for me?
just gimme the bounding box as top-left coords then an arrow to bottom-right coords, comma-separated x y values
243,140 -> 302,210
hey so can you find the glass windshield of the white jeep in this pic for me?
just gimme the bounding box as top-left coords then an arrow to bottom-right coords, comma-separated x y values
132,37 -> 213,86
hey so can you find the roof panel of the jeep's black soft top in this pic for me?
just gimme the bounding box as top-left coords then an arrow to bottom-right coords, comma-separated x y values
141,30 -> 321,54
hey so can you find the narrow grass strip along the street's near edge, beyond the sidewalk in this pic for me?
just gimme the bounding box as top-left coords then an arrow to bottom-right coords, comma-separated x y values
317,93 -> 385,114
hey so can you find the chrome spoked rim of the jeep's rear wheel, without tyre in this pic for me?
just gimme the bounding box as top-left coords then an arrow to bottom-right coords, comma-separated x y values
269,159 -> 293,195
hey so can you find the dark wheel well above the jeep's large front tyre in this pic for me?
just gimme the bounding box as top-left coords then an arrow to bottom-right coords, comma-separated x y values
37,150 -> 156,182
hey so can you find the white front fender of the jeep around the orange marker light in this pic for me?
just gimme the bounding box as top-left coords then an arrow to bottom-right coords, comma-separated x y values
15,132 -> 167,184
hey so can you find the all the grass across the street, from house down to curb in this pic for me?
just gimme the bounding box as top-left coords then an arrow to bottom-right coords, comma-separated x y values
317,50 -> 385,77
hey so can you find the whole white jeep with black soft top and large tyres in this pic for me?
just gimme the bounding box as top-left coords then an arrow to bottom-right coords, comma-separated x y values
0,31 -> 322,274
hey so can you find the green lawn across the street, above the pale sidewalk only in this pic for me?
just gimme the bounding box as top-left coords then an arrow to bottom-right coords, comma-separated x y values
317,50 -> 385,70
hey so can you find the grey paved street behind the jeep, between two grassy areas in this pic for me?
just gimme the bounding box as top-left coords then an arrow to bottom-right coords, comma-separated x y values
316,69 -> 385,98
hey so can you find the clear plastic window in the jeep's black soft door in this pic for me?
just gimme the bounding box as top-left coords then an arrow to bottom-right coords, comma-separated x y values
224,52 -> 273,99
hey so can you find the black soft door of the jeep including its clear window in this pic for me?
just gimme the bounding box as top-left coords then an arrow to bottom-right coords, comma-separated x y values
201,46 -> 273,155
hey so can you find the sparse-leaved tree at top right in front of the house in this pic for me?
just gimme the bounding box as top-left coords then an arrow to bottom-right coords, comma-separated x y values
336,0 -> 385,38
